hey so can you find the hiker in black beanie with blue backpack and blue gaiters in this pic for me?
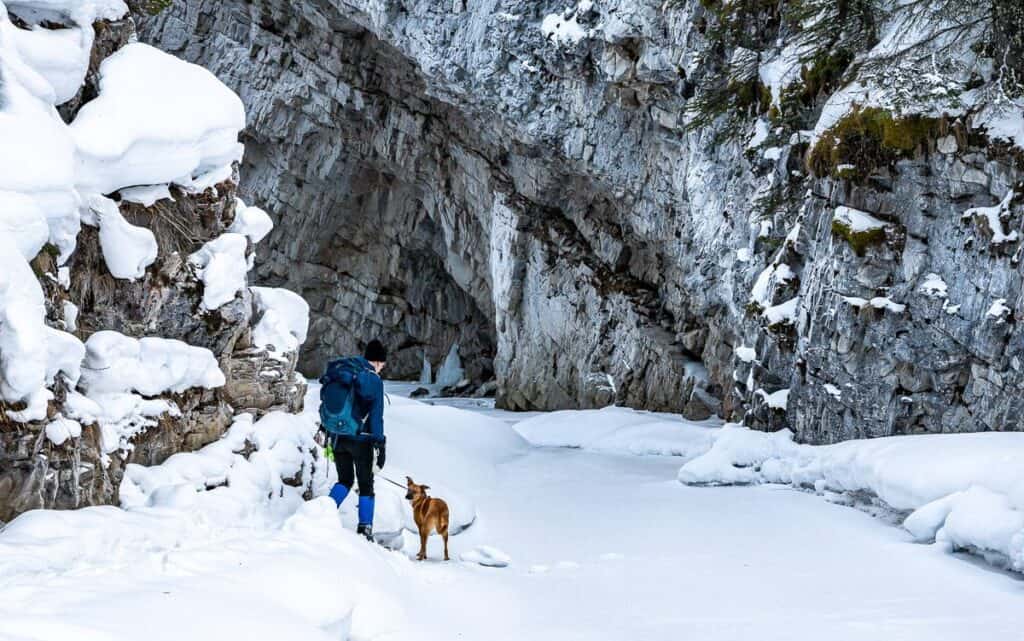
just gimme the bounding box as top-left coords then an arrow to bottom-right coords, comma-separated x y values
319,339 -> 387,541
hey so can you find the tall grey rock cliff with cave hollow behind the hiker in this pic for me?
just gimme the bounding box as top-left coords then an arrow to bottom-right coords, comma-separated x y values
142,0 -> 1024,442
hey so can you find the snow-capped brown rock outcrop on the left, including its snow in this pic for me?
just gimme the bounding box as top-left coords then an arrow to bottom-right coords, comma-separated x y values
0,0 -> 305,522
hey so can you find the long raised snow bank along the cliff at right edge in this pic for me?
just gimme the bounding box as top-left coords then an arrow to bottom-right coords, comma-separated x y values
679,425 -> 1024,571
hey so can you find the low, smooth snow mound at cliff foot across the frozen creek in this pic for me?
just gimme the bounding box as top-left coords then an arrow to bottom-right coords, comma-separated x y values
515,408 -> 716,459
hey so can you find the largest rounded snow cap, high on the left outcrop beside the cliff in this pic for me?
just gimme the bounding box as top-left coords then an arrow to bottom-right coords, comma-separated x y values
71,43 -> 246,194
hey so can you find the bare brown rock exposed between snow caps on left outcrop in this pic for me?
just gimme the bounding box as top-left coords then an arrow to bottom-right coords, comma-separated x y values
0,5 -> 305,522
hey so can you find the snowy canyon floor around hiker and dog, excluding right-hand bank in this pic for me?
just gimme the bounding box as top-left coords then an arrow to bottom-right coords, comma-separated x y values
0,386 -> 1024,641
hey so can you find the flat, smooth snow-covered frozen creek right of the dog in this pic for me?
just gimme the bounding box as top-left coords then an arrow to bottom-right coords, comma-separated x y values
399,434 -> 1024,641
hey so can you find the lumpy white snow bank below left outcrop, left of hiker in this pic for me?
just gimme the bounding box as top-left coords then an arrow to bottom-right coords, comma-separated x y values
0,413 -> 414,641
